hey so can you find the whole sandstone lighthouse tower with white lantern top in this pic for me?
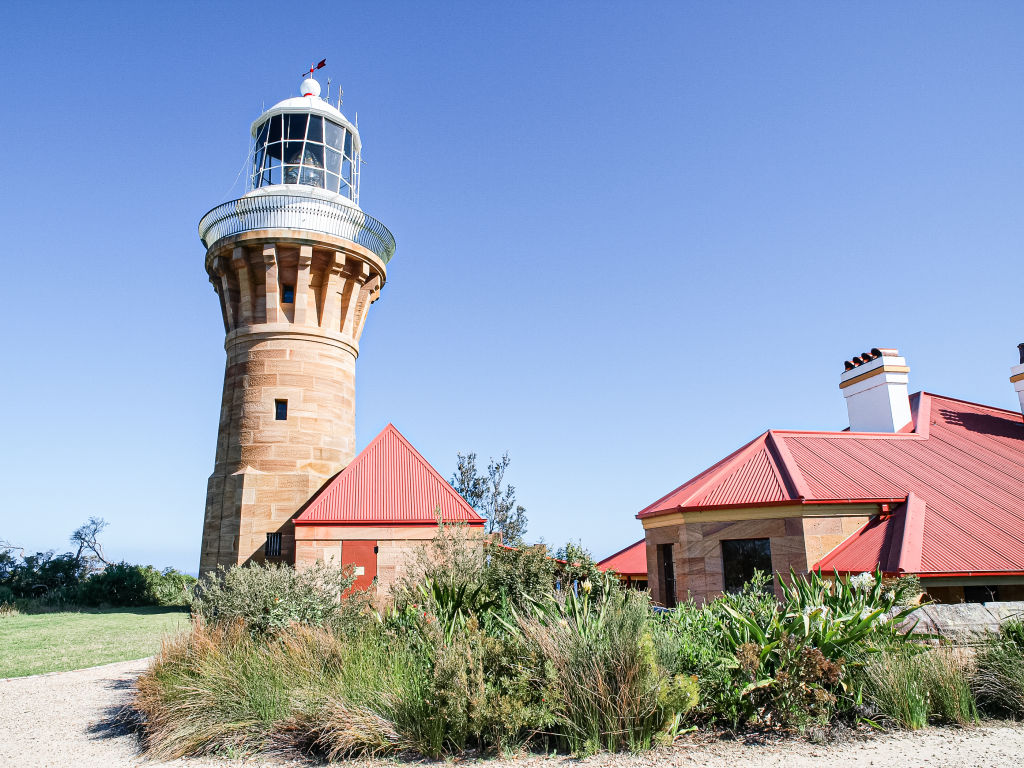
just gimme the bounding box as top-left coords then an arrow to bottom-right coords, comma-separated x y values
199,71 -> 394,573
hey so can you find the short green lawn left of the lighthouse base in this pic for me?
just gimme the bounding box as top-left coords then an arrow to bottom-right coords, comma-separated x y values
0,608 -> 188,678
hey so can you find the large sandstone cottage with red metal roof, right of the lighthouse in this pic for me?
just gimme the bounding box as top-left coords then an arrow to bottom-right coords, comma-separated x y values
637,350 -> 1024,602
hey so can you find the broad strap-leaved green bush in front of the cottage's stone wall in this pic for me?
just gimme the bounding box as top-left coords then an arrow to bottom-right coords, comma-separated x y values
657,573 -> 929,729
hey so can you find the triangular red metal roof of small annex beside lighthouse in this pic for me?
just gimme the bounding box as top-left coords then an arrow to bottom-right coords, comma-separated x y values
295,424 -> 484,526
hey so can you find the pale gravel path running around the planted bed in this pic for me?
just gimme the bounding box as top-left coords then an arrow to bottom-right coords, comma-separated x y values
0,659 -> 1024,768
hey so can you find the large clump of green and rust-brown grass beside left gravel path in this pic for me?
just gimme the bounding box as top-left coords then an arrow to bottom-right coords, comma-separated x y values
134,620 -> 429,760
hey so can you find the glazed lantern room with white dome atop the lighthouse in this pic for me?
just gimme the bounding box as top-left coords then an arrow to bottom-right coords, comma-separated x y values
250,78 -> 360,205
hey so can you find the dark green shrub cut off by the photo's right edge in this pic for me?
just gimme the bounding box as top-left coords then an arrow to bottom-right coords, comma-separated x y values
971,621 -> 1024,718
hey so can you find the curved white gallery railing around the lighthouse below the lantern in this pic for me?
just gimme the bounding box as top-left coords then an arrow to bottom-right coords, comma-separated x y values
199,195 -> 394,264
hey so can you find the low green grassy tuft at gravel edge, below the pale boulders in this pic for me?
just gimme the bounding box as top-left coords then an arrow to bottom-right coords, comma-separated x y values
859,643 -> 978,729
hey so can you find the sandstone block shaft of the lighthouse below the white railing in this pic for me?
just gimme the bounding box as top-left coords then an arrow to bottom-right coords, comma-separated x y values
200,229 -> 386,573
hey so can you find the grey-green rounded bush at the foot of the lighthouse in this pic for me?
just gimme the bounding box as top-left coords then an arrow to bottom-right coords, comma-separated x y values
191,562 -> 368,635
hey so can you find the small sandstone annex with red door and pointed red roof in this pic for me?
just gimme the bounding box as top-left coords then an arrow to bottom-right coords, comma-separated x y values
294,424 -> 484,592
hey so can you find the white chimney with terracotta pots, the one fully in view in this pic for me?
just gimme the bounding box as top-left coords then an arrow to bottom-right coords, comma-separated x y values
839,347 -> 913,432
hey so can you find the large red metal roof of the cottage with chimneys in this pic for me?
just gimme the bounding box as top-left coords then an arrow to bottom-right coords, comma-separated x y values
637,392 -> 1024,575
